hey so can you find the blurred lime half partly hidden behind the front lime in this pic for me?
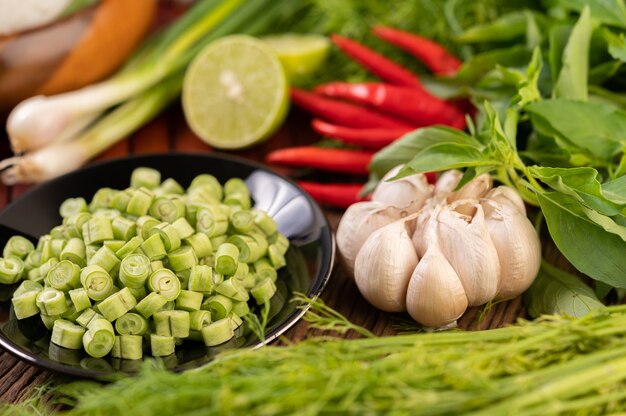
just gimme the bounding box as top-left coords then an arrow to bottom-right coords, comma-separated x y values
261,33 -> 330,81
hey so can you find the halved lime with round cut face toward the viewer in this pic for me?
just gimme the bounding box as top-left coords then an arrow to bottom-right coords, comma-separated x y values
182,35 -> 289,149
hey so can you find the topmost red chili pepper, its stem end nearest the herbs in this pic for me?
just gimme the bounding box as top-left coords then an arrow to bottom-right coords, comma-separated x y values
373,26 -> 462,75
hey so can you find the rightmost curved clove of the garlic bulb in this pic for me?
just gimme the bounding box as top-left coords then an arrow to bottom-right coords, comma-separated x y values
482,200 -> 541,300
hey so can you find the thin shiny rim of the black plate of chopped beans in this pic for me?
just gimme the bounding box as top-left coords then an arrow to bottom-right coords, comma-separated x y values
0,151 -> 336,379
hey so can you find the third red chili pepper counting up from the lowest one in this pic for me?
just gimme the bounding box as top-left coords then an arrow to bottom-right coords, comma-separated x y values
311,119 -> 413,150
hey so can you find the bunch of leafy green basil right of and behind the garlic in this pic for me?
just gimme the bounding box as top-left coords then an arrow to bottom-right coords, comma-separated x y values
370,0 -> 626,316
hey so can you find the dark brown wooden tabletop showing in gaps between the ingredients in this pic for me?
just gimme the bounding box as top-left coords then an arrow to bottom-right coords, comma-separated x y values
0,104 -> 532,402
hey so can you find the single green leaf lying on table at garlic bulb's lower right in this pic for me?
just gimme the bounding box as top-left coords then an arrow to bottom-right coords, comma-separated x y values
524,262 -> 604,318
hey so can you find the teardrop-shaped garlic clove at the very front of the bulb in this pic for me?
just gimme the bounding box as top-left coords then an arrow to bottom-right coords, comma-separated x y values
406,244 -> 468,328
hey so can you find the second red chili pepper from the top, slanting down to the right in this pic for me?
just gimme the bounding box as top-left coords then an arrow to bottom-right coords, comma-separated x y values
330,35 -> 422,87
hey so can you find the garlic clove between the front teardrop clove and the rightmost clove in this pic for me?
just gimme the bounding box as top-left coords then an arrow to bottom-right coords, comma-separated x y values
435,201 -> 500,306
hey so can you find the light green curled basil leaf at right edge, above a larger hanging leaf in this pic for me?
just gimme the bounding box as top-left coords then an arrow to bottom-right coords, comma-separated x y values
529,166 -> 626,216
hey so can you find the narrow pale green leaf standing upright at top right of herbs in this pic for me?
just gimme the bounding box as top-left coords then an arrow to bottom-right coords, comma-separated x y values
552,7 -> 592,101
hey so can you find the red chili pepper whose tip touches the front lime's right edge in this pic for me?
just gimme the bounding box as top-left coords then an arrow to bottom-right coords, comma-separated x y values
291,88 -> 414,128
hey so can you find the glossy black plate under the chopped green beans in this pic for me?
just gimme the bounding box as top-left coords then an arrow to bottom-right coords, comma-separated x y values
0,153 -> 334,377
